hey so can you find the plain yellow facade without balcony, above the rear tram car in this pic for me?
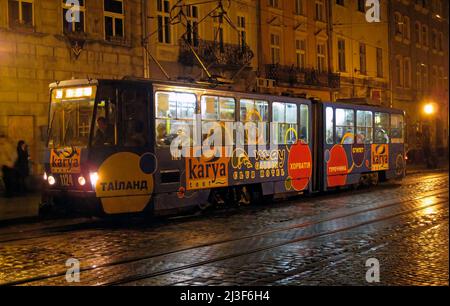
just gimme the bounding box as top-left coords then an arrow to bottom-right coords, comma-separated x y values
330,0 -> 390,106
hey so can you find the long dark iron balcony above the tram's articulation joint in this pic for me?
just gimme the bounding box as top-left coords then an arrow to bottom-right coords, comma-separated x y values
266,65 -> 340,89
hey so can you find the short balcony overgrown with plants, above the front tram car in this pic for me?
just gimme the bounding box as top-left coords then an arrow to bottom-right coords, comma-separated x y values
178,39 -> 254,70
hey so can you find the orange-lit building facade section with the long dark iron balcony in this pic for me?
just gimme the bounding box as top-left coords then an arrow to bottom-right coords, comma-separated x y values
258,0 -> 339,100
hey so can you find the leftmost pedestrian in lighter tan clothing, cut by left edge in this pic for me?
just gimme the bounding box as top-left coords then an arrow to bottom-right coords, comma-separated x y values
0,134 -> 17,197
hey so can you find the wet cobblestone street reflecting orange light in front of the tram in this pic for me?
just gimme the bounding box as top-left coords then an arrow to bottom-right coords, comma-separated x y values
0,172 -> 449,286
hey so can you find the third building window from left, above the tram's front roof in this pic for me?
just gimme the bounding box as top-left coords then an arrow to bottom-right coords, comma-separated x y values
104,0 -> 125,40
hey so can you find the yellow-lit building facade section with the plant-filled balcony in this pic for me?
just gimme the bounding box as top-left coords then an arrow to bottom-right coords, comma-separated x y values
144,0 -> 259,91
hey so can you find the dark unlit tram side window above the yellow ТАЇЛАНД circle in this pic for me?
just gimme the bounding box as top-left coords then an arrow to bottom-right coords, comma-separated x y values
122,88 -> 148,147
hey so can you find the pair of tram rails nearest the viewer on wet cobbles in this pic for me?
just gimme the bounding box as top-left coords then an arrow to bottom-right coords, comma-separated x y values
0,188 -> 448,285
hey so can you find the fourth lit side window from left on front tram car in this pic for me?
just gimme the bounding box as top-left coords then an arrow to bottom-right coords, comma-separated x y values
272,102 -> 298,145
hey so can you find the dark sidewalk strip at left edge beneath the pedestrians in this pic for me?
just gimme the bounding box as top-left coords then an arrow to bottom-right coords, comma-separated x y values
0,194 -> 41,224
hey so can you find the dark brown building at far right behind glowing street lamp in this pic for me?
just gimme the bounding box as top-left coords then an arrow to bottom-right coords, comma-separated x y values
389,0 -> 449,160
